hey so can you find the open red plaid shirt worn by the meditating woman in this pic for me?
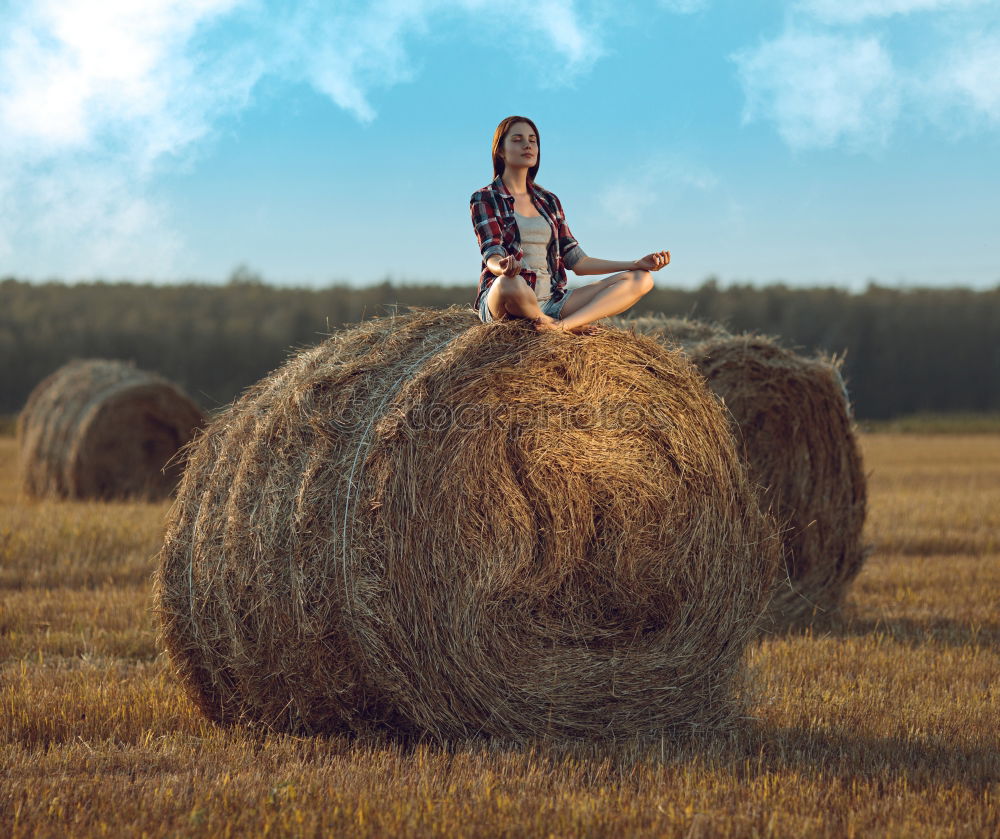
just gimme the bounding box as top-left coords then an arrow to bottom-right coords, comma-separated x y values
469,175 -> 586,309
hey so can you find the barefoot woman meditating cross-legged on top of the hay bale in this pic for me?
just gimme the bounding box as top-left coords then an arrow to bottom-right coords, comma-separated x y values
471,116 -> 670,332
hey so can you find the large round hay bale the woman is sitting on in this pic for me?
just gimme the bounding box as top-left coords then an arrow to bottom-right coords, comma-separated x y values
155,308 -> 779,740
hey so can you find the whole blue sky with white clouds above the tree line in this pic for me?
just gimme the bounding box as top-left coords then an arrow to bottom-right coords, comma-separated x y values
0,0 -> 1000,293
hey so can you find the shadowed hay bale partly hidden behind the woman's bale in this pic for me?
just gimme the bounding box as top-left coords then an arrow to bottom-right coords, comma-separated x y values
615,316 -> 867,627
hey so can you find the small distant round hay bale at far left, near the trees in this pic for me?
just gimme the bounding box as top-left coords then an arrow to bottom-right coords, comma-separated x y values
17,359 -> 205,500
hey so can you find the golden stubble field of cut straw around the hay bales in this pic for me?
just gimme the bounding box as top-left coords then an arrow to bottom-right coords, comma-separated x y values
0,434 -> 1000,837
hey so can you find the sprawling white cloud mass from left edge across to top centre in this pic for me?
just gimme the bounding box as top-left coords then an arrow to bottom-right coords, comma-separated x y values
0,0 -> 603,276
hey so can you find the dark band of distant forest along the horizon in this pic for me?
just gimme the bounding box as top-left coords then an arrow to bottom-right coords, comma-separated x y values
0,272 -> 1000,419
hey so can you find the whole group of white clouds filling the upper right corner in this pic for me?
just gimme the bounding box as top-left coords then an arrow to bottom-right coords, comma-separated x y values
732,0 -> 1000,150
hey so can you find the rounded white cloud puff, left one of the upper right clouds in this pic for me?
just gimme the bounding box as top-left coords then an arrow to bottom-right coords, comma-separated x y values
733,31 -> 899,149
